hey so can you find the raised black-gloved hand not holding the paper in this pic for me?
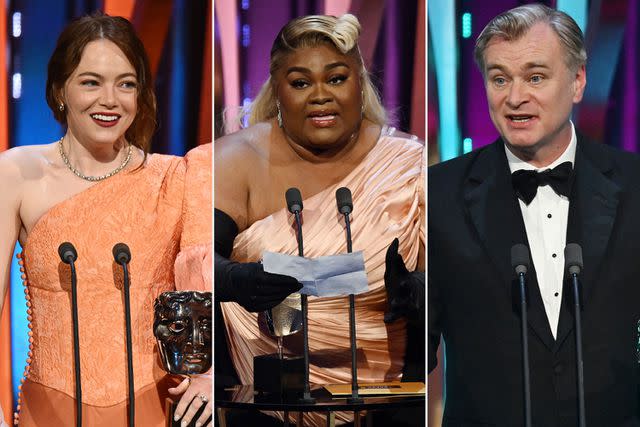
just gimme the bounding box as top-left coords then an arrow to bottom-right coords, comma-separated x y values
384,238 -> 425,324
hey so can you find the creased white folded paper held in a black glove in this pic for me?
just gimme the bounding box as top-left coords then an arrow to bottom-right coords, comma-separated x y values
262,251 -> 369,297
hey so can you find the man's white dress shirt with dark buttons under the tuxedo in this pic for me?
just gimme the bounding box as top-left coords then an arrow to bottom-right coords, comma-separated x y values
505,123 -> 577,338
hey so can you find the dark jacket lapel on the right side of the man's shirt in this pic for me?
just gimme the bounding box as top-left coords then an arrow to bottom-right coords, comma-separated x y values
556,138 -> 621,349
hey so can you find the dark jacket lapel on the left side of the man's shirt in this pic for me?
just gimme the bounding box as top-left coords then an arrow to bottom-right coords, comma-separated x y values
464,140 -> 554,349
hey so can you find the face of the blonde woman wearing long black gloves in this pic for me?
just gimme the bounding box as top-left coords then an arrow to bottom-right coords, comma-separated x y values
275,44 -> 362,150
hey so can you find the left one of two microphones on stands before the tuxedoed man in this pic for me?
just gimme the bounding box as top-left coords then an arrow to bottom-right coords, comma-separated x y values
511,243 -> 531,427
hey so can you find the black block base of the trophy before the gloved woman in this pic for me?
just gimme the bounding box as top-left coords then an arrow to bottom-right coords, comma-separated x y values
253,354 -> 304,396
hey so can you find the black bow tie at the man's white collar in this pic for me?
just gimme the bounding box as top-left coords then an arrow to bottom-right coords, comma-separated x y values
511,162 -> 574,205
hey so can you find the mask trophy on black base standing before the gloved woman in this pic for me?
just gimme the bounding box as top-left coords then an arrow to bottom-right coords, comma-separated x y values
253,293 -> 304,395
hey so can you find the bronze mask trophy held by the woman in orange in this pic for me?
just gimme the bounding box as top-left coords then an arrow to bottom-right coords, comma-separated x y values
153,291 -> 212,427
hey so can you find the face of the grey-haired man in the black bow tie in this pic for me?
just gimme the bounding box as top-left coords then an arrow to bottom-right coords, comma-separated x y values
484,23 -> 586,166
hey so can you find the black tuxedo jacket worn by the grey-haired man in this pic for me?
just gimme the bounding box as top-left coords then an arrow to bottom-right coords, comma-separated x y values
427,137 -> 640,427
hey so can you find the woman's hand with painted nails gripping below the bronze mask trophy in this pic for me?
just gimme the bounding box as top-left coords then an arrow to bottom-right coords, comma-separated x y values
168,374 -> 213,427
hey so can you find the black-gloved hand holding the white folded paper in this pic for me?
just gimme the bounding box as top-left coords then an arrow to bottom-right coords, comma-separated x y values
214,252 -> 302,312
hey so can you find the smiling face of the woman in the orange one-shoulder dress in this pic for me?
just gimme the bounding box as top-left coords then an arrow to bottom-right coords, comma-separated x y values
60,39 -> 138,149
